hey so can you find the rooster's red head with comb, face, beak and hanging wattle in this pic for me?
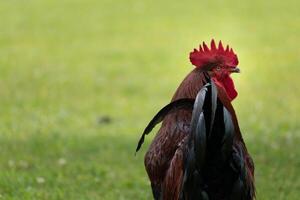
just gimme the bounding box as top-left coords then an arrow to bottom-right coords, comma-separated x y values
190,40 -> 240,101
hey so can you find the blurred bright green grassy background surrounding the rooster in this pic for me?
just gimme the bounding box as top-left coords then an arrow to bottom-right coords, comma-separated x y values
0,0 -> 300,200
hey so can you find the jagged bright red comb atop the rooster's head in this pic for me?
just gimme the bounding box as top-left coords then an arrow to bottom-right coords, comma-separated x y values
190,39 -> 239,67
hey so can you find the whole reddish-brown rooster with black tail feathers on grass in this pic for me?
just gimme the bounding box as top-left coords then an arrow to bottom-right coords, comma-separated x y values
136,40 -> 255,200
